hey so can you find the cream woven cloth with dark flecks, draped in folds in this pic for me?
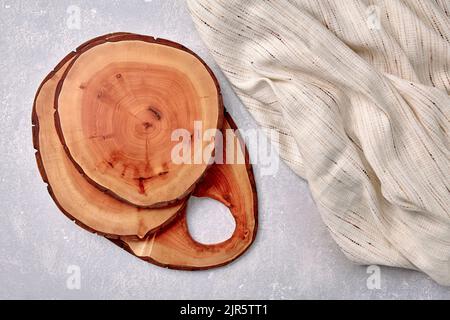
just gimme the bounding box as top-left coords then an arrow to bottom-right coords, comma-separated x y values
188,0 -> 450,285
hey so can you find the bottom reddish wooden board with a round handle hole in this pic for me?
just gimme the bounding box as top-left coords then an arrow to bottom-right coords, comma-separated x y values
113,114 -> 258,270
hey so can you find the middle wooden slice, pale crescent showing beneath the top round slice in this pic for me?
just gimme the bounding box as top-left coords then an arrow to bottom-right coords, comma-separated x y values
32,33 -> 185,238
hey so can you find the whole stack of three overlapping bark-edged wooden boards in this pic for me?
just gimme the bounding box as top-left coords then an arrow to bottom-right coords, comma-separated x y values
32,33 -> 257,270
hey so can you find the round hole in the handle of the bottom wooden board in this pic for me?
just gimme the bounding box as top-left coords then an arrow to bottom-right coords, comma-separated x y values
187,197 -> 236,245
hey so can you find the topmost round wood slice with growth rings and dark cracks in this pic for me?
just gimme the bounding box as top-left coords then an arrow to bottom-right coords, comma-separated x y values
55,34 -> 223,207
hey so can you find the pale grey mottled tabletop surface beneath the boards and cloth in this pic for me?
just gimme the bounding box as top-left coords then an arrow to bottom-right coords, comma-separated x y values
0,0 -> 450,299
